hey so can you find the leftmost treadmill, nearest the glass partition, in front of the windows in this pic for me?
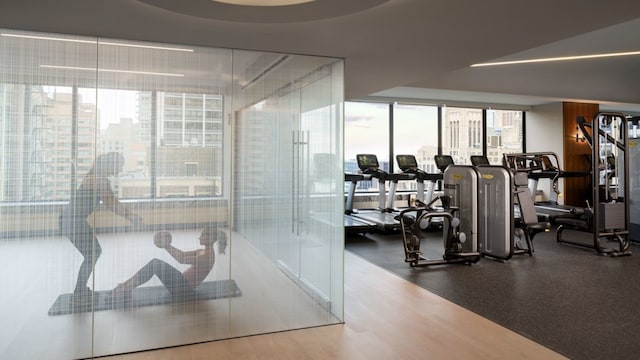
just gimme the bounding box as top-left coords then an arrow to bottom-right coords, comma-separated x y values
346,154 -> 415,232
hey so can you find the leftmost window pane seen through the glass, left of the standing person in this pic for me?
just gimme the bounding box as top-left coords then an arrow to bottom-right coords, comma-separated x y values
0,83 -> 79,202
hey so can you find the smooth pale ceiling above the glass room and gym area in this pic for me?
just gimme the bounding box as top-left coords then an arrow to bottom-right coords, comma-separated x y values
0,0 -> 640,111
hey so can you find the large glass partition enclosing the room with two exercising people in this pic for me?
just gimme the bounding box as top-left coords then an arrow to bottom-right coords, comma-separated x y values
0,30 -> 344,359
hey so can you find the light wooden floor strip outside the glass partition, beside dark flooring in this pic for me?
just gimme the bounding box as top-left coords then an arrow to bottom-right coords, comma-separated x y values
107,252 -> 564,360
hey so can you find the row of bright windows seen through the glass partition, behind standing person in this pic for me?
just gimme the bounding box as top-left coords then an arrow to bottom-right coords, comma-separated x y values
0,84 -> 223,202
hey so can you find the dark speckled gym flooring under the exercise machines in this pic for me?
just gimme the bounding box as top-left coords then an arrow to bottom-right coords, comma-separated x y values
345,230 -> 640,359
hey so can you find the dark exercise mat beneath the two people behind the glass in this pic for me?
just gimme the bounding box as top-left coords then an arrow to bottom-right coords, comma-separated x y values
49,280 -> 242,315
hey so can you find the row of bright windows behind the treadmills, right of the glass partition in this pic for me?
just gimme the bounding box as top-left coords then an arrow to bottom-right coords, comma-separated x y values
345,102 -> 524,191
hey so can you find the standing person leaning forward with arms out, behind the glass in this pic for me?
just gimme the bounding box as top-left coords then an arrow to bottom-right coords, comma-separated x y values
60,152 -> 141,300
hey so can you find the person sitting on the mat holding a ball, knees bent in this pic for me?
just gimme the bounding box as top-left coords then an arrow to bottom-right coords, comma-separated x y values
113,226 -> 227,300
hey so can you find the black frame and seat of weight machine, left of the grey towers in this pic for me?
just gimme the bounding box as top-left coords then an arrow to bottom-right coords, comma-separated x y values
396,195 -> 480,267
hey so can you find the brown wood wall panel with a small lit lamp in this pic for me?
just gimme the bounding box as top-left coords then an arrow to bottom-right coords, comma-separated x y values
562,102 -> 600,207
